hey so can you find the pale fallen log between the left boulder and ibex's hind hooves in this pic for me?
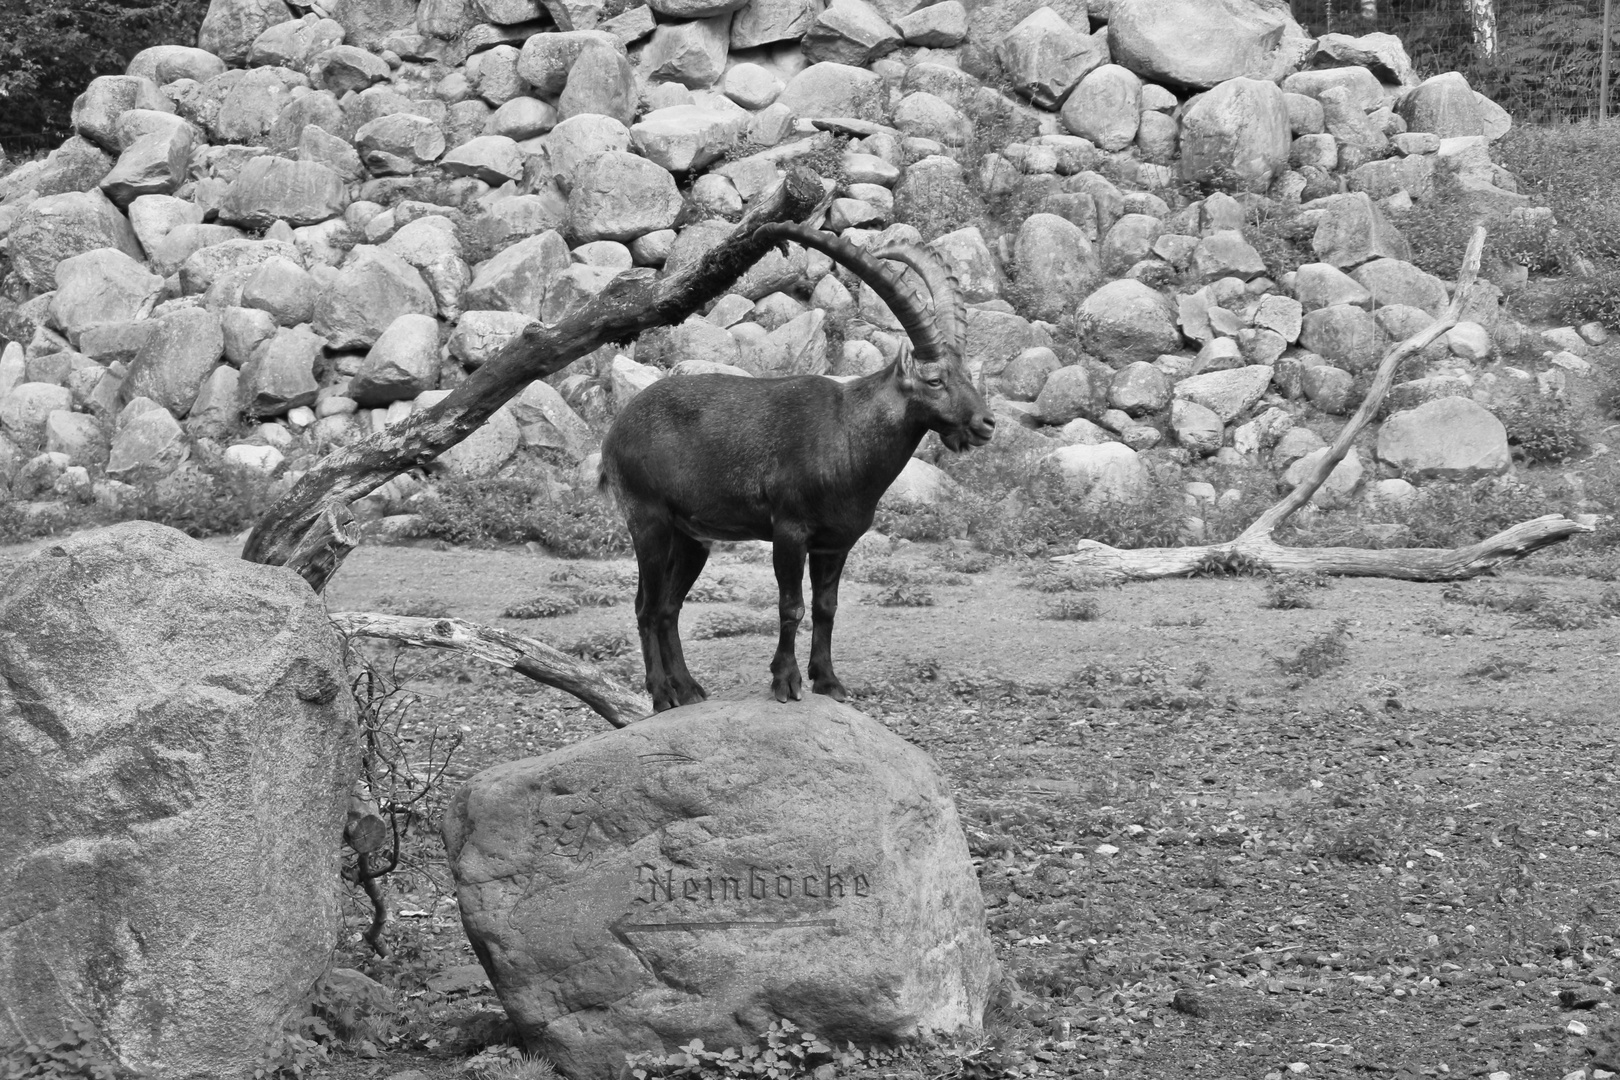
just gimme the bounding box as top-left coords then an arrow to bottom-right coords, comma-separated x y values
330,612 -> 653,727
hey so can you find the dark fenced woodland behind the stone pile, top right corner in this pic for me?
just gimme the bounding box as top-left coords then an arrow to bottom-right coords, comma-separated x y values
1290,0 -> 1620,123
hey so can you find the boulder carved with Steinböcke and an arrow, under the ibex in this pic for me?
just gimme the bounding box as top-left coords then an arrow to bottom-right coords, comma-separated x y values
444,695 -> 995,1080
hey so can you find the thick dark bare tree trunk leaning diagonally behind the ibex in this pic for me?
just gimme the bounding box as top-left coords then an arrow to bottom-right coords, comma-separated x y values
241,167 -> 823,593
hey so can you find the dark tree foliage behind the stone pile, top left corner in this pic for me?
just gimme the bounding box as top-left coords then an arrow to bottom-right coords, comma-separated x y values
0,0 -> 207,152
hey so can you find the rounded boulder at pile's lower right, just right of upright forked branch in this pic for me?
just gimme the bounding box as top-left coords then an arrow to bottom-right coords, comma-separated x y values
1379,397 -> 1513,481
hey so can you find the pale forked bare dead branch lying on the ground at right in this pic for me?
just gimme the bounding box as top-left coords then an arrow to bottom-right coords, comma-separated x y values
1053,228 -> 1592,581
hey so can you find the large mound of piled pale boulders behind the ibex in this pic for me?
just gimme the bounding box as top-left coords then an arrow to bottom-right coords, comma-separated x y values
0,0 -> 1591,527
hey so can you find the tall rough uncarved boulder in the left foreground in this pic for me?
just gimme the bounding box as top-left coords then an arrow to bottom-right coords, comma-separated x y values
0,518 -> 358,1077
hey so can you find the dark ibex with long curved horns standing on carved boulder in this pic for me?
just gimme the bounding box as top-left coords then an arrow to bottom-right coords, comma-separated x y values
601,223 -> 995,711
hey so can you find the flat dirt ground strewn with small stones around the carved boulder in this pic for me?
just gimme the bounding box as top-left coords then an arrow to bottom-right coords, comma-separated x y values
11,541 -> 1620,1080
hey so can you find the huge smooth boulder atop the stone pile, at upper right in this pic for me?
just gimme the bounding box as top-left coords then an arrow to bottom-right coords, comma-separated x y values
1108,0 -> 1311,89
